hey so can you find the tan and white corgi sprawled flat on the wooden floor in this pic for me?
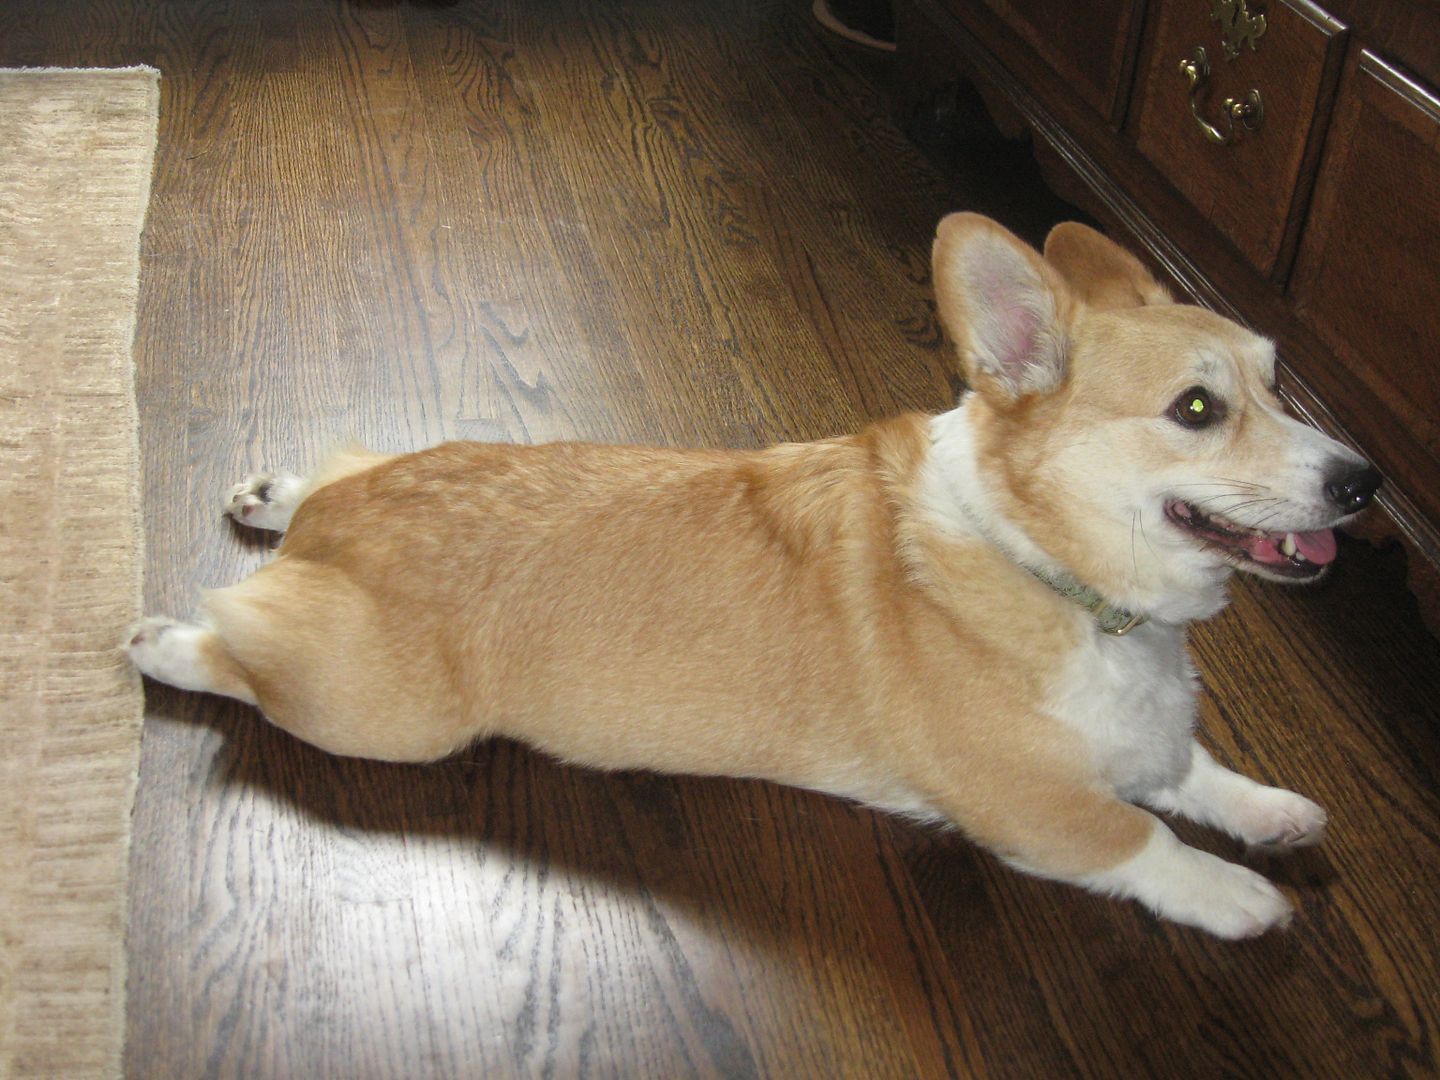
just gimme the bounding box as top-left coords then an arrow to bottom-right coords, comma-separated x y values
125,213 -> 1380,939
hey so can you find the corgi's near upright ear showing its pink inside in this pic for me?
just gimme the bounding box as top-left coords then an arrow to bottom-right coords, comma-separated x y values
933,213 -> 1071,402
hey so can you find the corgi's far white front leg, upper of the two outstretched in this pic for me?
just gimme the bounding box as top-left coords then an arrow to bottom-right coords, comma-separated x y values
1143,743 -> 1325,851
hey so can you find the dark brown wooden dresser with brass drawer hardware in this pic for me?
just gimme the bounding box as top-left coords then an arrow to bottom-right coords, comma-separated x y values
897,0 -> 1440,616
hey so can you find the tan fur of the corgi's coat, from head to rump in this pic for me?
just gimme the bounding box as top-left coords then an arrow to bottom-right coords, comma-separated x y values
132,215 -> 1370,933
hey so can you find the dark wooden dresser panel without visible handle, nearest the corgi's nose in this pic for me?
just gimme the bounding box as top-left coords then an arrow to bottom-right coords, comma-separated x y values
1290,52 -> 1440,494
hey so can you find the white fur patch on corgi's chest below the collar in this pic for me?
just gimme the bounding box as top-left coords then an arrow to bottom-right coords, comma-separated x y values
1050,624 -> 1200,799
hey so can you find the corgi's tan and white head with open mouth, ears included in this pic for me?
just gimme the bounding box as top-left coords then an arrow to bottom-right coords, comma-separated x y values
935,213 -> 1380,615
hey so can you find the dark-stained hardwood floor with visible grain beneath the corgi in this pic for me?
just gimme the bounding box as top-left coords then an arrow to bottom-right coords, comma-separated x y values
0,0 -> 1440,1077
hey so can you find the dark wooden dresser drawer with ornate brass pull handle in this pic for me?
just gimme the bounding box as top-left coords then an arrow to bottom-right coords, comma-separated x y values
1133,0 -> 1345,278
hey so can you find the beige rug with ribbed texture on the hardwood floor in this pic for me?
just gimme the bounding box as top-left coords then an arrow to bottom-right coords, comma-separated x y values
0,68 -> 160,1077
